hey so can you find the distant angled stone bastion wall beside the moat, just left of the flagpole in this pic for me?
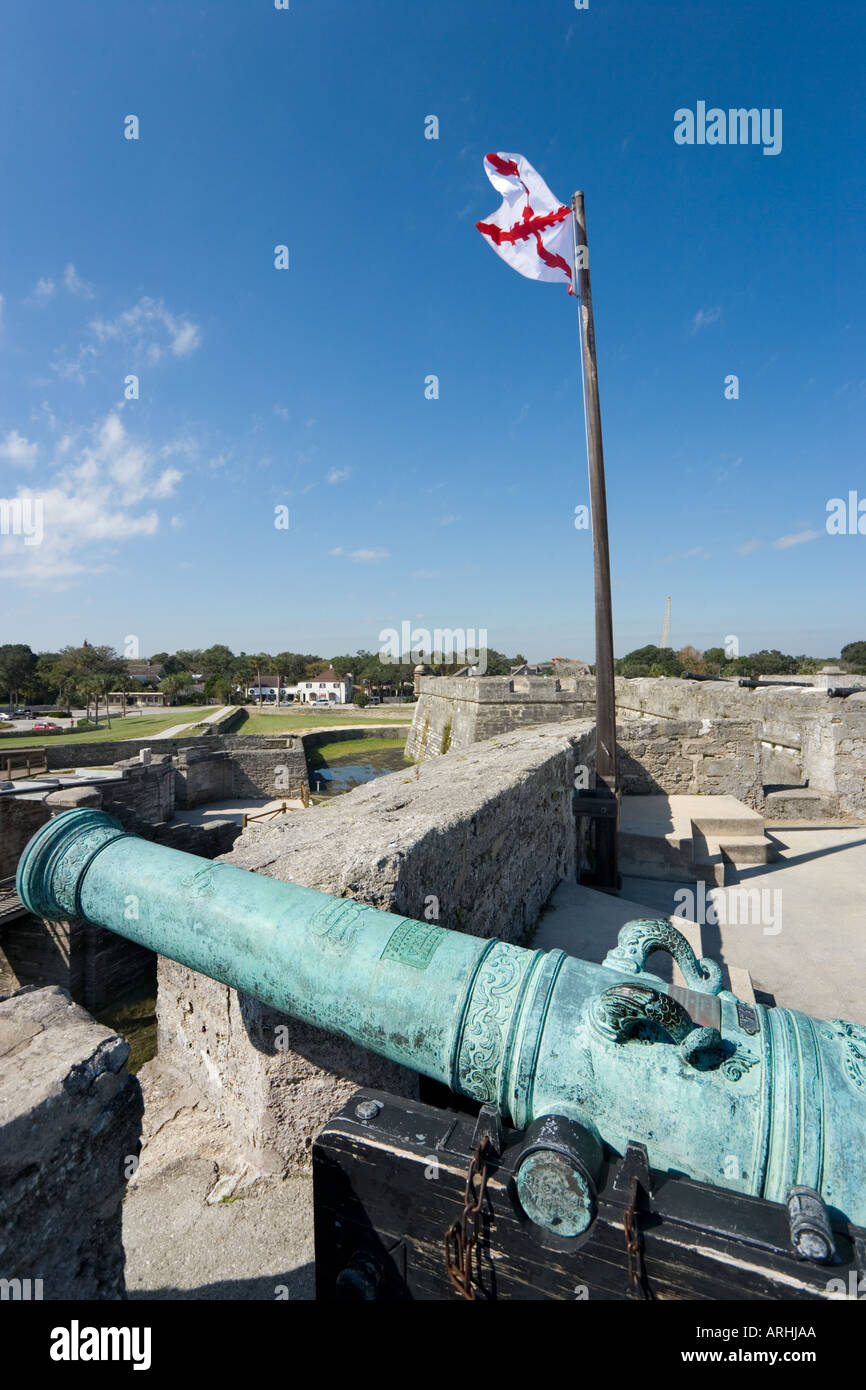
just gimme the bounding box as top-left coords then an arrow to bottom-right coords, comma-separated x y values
406,676 -> 595,763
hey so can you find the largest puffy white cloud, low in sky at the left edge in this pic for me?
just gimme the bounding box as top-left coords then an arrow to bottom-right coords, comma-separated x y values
0,410 -> 187,589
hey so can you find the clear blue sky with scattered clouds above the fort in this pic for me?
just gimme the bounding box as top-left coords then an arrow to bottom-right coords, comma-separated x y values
0,0 -> 866,659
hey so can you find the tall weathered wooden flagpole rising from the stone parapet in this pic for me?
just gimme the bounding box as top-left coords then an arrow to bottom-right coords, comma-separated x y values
571,192 -> 619,890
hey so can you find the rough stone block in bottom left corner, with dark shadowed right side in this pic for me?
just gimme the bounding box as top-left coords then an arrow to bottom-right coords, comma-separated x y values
0,988 -> 142,1300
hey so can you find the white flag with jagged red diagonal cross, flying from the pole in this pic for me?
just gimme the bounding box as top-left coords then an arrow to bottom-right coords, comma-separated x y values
475,154 -> 574,295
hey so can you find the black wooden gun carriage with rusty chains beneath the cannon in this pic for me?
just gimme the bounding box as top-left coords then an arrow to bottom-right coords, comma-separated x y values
313,1090 -> 866,1301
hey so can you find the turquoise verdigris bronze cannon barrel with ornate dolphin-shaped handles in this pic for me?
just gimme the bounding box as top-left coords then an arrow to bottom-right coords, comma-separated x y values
18,809 -> 866,1233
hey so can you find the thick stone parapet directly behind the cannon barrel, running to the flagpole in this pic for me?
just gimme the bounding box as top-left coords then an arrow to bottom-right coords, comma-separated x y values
157,723 -> 595,1172
